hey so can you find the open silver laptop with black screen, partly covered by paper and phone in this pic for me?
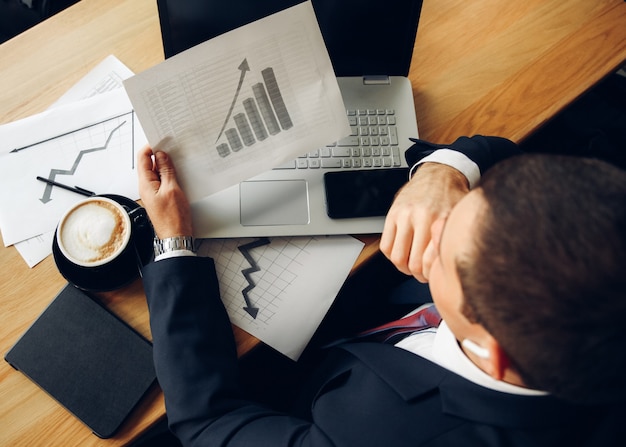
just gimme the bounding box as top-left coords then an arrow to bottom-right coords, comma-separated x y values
157,0 -> 422,238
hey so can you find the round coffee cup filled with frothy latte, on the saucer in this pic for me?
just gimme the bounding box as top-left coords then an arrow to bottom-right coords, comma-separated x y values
56,196 -> 132,267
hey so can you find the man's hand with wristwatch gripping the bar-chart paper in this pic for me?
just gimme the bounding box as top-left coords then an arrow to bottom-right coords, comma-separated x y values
137,146 -> 193,239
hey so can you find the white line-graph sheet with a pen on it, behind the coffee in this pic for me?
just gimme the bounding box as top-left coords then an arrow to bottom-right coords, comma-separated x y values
0,89 -> 146,246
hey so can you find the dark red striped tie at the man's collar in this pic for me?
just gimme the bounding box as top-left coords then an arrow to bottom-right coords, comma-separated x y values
356,304 -> 441,344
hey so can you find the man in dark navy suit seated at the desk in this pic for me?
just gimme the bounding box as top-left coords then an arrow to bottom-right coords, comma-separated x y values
138,137 -> 626,447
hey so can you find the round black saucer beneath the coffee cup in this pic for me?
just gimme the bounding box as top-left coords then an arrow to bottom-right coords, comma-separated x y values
52,194 -> 154,292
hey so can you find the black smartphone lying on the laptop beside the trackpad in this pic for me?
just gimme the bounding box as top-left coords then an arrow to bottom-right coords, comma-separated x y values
324,168 -> 409,219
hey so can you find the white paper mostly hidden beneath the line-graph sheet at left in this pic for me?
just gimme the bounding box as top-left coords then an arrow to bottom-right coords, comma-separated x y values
14,55 -> 134,268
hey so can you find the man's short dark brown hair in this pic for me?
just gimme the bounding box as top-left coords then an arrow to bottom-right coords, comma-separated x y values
457,154 -> 626,403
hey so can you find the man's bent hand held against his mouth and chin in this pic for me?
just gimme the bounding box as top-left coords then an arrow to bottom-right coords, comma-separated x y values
380,163 -> 469,282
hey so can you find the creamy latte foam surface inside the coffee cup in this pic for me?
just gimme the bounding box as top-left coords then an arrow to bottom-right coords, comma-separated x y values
60,200 -> 129,263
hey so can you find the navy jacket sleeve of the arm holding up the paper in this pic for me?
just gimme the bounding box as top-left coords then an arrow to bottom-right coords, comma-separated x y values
143,257 -> 330,446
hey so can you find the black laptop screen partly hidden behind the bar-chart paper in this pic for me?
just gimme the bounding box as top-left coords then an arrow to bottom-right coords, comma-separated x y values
157,0 -> 422,76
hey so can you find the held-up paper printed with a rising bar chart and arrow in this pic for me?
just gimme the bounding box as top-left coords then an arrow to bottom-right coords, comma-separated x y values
124,2 -> 350,202
